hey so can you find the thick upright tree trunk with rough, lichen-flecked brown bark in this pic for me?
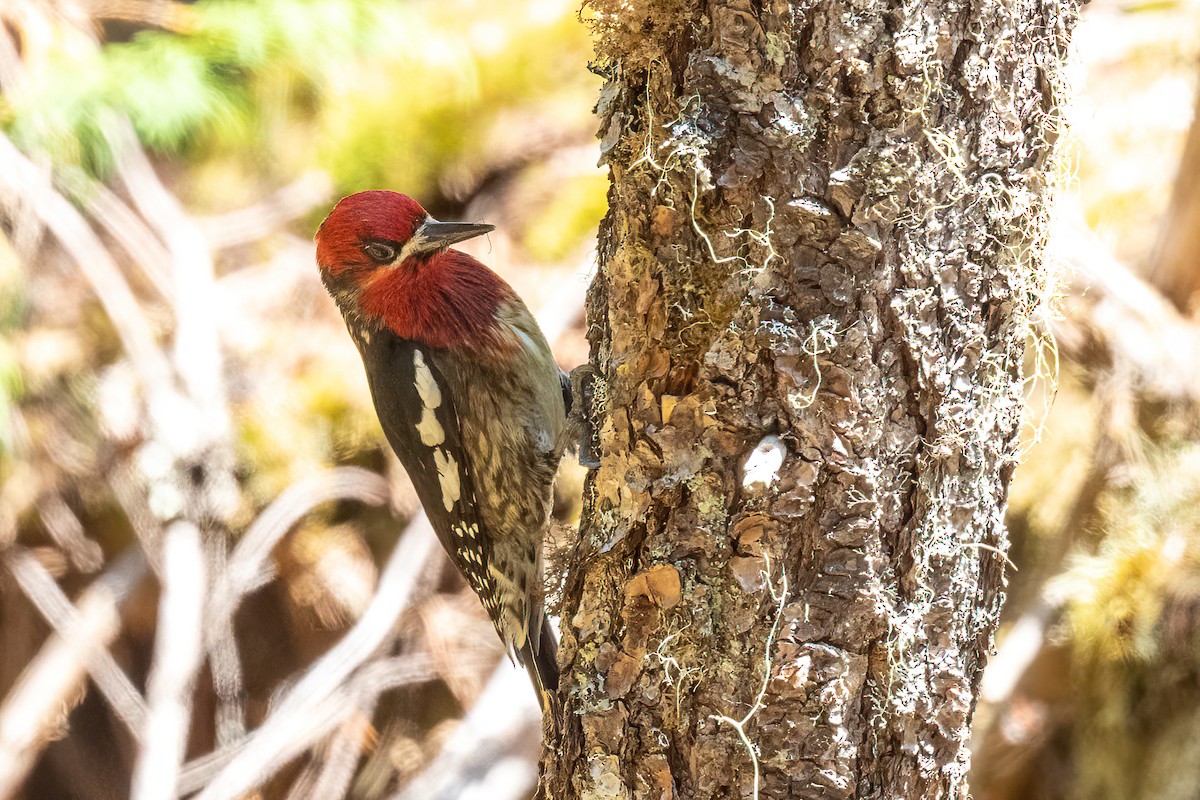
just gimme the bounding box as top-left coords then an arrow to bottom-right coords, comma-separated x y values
544,0 -> 1076,800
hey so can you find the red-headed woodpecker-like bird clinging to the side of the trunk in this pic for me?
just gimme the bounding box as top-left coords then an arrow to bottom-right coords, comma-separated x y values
314,191 -> 571,712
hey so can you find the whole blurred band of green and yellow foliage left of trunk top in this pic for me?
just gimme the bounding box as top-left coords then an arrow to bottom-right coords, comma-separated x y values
0,0 -> 596,206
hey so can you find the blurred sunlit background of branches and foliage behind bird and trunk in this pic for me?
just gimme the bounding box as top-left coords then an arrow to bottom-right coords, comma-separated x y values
0,0 -> 1200,800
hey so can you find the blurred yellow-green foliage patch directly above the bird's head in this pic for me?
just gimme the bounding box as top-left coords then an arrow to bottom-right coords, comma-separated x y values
317,1 -> 599,196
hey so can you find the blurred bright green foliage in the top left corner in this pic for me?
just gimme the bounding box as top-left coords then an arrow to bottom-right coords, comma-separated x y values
0,0 -> 379,174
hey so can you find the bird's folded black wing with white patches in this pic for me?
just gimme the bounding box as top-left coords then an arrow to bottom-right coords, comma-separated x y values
355,330 -> 500,621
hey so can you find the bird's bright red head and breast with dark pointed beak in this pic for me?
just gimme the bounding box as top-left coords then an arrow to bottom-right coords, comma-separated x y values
316,191 -> 514,347
